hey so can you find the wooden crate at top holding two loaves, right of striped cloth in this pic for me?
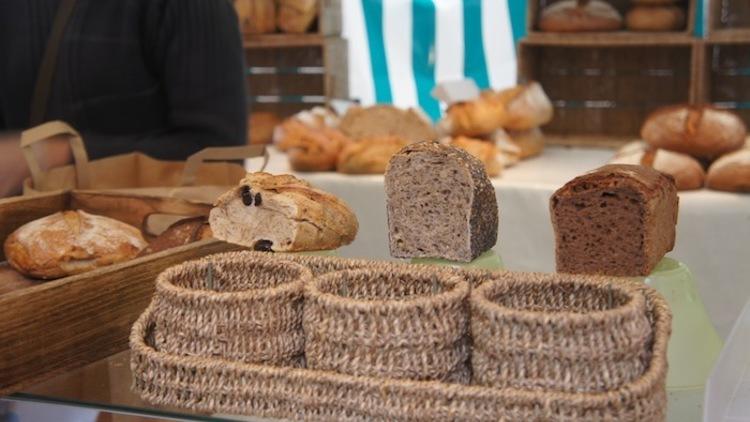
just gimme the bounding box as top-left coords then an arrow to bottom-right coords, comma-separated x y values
526,0 -> 700,39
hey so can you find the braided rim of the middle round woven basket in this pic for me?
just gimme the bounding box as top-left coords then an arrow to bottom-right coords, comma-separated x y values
305,266 -> 470,311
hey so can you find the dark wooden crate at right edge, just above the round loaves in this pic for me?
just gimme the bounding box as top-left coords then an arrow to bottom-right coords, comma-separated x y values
699,40 -> 750,127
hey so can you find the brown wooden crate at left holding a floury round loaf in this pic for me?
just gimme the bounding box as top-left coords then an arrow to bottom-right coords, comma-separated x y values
0,192 -> 242,396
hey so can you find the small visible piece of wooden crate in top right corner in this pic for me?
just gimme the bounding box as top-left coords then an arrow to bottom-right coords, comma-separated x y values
705,0 -> 750,41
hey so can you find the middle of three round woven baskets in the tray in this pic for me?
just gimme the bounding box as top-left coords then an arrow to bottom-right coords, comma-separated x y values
303,266 -> 469,381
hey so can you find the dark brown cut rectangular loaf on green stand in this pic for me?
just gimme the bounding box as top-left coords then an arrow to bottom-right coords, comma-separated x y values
550,164 -> 678,277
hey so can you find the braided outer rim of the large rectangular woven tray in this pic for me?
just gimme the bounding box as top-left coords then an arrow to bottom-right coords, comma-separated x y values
129,276 -> 672,408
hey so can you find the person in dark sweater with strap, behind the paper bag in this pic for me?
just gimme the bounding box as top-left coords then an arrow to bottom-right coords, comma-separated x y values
0,0 -> 247,197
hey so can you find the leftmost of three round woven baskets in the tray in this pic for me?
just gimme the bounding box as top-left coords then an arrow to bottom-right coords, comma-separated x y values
152,255 -> 312,366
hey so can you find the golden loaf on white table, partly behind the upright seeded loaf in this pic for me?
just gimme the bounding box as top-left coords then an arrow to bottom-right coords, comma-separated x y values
336,136 -> 409,174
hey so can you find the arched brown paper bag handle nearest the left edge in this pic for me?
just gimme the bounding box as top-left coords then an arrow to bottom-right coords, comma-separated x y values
21,120 -> 91,189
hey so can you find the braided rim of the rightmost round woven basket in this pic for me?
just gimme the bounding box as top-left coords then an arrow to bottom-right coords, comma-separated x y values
470,273 -> 646,326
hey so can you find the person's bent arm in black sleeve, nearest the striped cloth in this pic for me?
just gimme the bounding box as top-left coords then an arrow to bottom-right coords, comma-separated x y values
82,0 -> 247,159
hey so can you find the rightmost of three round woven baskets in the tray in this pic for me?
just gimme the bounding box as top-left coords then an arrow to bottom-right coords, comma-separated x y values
471,274 -> 653,392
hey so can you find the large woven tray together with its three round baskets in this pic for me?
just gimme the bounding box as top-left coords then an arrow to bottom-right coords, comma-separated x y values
130,252 -> 671,421
